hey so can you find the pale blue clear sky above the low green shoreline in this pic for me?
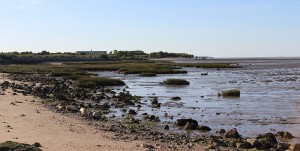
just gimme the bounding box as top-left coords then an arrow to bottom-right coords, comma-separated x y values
0,0 -> 300,57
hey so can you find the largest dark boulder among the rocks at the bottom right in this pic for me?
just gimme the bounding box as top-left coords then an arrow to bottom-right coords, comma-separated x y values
256,133 -> 278,149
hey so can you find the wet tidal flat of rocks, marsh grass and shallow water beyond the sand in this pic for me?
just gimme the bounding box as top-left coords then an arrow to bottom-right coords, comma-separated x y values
1,59 -> 300,149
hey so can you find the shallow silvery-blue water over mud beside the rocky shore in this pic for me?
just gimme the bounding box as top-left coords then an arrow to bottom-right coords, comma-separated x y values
98,64 -> 300,142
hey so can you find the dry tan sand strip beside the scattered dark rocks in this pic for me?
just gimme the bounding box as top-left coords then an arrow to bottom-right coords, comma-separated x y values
0,74 -> 145,151
